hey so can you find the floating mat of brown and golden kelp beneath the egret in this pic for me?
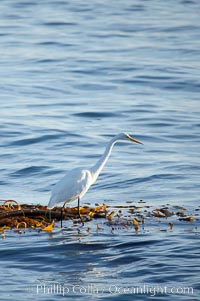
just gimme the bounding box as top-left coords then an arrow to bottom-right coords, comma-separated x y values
0,200 -> 200,237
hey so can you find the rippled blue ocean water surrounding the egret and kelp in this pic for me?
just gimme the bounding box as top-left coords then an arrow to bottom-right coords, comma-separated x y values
0,0 -> 200,300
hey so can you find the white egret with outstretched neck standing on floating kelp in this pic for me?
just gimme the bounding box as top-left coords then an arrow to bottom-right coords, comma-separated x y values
48,133 -> 143,224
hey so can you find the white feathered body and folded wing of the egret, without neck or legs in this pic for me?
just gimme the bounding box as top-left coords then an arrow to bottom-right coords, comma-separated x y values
48,168 -> 91,208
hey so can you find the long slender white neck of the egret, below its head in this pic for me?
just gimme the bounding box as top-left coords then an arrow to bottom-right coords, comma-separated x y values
91,137 -> 118,181
